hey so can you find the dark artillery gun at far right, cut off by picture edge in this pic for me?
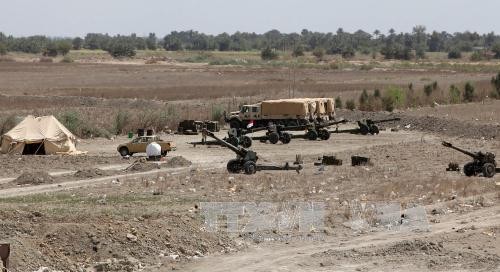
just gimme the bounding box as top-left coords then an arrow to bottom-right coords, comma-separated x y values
442,142 -> 500,178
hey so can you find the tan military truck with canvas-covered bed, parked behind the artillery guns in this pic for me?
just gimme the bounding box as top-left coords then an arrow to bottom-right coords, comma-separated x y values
224,98 -> 335,129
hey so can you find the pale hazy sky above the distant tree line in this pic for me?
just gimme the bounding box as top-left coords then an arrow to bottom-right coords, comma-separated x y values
0,0 -> 500,36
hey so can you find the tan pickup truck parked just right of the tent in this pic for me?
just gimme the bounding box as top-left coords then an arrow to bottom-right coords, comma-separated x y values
116,135 -> 176,157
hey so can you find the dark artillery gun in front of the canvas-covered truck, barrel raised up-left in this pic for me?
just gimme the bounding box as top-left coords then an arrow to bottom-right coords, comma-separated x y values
204,131 -> 302,175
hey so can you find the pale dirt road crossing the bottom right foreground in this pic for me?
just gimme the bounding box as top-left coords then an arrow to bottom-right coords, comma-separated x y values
185,206 -> 500,272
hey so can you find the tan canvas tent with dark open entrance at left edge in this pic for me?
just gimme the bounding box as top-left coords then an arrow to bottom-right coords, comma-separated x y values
1,115 -> 81,155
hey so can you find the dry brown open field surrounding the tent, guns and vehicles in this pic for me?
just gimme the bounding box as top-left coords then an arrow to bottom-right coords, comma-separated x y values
0,54 -> 500,271
